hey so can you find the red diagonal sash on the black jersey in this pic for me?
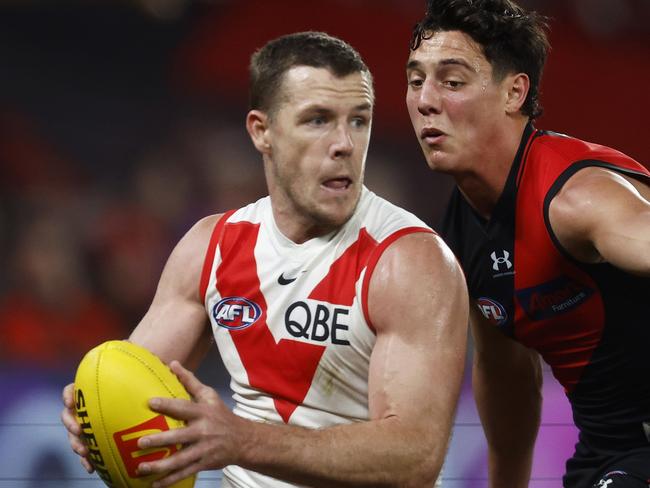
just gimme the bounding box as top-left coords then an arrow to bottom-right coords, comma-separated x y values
514,136 -> 612,393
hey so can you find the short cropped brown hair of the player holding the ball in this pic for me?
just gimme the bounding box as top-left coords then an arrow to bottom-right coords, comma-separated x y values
249,31 -> 372,114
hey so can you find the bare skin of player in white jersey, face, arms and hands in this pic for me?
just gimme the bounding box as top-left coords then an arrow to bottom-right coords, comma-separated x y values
62,67 -> 468,487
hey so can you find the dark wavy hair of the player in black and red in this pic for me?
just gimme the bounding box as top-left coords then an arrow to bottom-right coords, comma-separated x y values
410,0 -> 550,119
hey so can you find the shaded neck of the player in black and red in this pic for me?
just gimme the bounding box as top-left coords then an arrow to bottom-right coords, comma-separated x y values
454,118 -> 528,219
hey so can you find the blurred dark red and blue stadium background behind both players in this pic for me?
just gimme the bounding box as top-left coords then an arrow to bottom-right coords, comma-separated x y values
0,0 -> 650,488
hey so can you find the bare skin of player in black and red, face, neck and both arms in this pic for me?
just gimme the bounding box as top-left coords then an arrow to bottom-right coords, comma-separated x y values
406,25 -> 650,488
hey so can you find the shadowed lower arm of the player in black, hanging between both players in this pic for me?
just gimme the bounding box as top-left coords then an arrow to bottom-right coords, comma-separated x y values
470,307 -> 542,488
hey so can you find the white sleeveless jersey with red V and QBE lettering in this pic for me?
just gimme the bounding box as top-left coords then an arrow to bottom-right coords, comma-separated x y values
201,188 -> 432,488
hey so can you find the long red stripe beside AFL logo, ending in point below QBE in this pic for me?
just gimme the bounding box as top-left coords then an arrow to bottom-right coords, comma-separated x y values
217,222 -> 325,423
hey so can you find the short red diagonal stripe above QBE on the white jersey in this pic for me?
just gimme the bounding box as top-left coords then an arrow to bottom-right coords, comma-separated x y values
309,228 -> 377,307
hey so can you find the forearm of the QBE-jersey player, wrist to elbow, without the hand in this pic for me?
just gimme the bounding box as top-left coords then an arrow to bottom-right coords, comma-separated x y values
238,418 -> 449,487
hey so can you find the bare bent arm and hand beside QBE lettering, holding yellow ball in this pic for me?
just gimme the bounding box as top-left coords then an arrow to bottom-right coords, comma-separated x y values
135,233 -> 468,487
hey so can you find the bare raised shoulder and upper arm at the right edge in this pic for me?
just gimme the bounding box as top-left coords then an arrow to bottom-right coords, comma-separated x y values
549,167 -> 650,276
